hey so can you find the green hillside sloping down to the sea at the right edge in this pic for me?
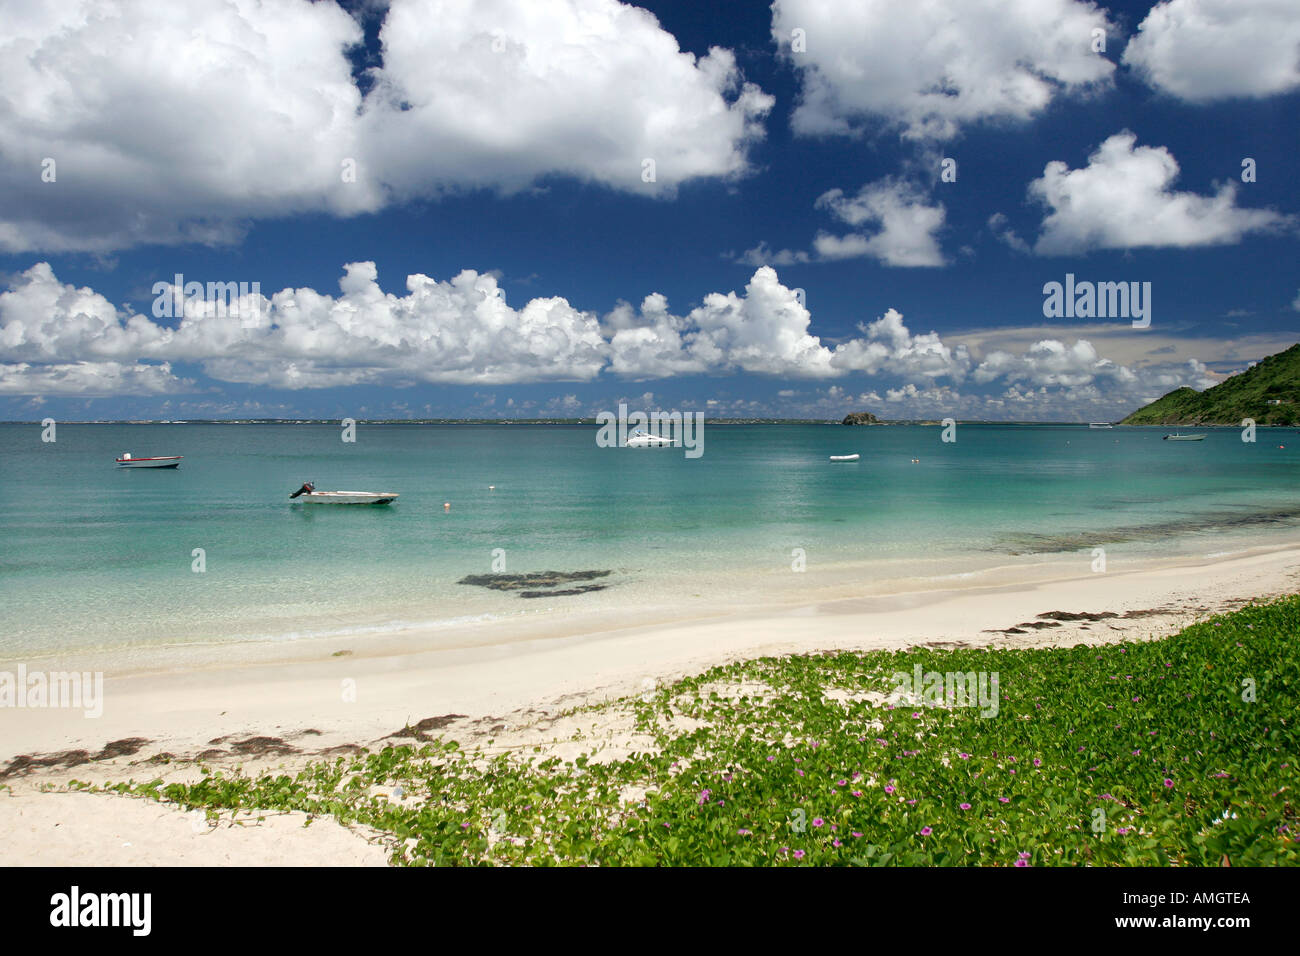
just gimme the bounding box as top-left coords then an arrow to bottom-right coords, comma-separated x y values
1119,345 -> 1300,425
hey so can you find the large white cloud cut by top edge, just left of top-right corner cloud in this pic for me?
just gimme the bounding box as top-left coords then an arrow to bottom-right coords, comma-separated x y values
772,0 -> 1114,139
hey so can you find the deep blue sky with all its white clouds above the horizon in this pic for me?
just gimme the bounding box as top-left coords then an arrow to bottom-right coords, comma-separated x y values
0,0 -> 1300,421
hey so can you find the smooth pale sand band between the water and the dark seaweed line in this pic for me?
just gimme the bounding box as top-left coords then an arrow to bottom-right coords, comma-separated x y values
0,544 -> 1300,771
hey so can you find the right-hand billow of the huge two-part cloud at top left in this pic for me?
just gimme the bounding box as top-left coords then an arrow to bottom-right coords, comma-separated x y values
361,0 -> 774,195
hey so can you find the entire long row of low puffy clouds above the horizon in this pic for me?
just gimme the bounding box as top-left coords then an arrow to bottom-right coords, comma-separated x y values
0,261 -> 1218,418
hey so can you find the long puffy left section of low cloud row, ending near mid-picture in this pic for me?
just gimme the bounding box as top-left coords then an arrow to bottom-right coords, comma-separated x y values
0,263 -> 607,389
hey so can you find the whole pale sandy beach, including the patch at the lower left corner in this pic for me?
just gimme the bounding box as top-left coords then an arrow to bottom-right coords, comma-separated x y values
0,546 -> 1300,865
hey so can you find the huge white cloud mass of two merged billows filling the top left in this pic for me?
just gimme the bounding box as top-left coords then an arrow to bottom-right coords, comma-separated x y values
0,0 -> 772,251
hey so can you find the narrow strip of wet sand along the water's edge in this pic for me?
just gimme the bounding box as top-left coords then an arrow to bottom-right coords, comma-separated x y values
0,527 -> 1300,676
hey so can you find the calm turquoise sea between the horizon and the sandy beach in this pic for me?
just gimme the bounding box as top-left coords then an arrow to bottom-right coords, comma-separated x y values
0,423 -> 1300,658
